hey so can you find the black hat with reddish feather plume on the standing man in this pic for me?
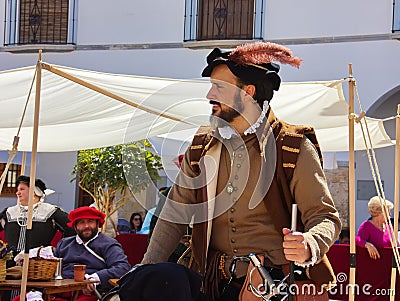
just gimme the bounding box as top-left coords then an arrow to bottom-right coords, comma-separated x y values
201,42 -> 302,91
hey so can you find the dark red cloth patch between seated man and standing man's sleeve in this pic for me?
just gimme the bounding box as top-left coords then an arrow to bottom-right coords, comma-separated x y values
115,234 -> 149,266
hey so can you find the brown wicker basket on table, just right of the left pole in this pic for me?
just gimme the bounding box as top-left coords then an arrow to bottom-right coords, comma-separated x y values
28,247 -> 58,280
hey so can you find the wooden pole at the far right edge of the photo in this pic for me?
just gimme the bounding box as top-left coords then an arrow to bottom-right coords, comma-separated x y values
390,105 -> 400,301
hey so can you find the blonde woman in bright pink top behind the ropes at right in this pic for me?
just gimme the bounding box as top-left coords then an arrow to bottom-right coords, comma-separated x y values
356,196 -> 393,259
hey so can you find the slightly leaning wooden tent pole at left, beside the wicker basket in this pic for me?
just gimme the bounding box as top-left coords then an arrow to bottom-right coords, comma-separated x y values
20,50 -> 42,301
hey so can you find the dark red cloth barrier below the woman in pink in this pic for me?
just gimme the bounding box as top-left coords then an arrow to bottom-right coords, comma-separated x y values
327,245 -> 400,301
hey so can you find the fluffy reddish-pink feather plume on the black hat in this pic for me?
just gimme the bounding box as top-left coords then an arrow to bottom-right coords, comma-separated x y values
228,42 -> 303,68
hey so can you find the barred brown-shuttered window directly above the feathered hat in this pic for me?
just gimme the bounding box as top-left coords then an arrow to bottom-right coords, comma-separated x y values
184,0 -> 264,41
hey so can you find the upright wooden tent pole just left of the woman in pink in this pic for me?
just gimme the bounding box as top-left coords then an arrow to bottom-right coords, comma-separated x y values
349,64 -> 356,301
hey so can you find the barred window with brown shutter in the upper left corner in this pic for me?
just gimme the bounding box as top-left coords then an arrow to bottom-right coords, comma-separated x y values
4,0 -> 76,46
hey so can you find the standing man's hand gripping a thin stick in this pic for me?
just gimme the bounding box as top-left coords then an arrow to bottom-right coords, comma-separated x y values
282,228 -> 311,263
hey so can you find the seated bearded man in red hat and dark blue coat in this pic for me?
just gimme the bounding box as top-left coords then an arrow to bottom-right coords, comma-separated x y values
54,207 -> 130,301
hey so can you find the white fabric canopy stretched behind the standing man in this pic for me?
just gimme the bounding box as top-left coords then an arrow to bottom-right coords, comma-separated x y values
0,64 -> 393,152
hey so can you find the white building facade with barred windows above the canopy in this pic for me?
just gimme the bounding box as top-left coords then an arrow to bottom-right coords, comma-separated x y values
0,0 -> 400,225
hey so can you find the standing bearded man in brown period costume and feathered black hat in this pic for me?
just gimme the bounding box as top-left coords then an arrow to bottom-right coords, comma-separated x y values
143,42 -> 341,301
